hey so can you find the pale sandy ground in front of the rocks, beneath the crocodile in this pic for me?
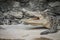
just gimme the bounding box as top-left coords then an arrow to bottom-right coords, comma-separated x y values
0,25 -> 60,40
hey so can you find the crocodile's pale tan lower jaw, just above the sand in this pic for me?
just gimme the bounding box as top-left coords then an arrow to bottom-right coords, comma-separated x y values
24,21 -> 50,28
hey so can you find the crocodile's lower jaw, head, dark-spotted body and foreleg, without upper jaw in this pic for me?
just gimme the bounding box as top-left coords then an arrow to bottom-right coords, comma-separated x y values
24,12 -> 58,35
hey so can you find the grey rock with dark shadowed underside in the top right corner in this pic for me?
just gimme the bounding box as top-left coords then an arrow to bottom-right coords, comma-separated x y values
49,1 -> 60,15
